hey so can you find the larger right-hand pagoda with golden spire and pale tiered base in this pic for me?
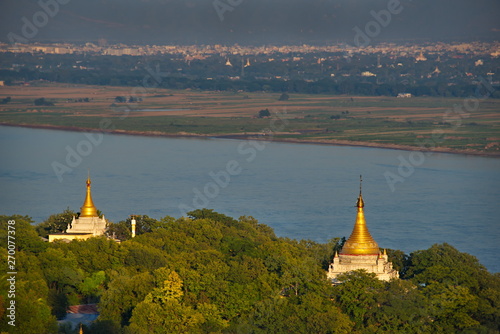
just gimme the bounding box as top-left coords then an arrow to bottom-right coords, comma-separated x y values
327,177 -> 399,283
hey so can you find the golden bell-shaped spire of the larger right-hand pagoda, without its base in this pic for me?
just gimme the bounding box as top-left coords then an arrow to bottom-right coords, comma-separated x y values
341,175 -> 380,255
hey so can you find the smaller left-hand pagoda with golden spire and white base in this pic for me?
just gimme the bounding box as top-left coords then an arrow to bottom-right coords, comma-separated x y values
49,174 -> 107,242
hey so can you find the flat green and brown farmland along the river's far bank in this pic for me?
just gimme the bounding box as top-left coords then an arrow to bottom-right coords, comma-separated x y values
0,83 -> 500,156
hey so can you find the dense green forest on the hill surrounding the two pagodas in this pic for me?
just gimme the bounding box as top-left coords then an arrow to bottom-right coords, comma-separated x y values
0,209 -> 500,334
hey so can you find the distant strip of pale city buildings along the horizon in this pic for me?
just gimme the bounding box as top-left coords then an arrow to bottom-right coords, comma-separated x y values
0,39 -> 500,57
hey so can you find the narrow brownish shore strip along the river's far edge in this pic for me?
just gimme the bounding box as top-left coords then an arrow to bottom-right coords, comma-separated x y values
0,122 -> 500,158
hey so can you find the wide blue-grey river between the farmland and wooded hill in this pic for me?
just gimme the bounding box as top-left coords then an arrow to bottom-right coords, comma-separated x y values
0,126 -> 500,272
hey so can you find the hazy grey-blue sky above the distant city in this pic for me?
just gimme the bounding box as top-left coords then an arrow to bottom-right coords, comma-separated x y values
0,0 -> 500,44
